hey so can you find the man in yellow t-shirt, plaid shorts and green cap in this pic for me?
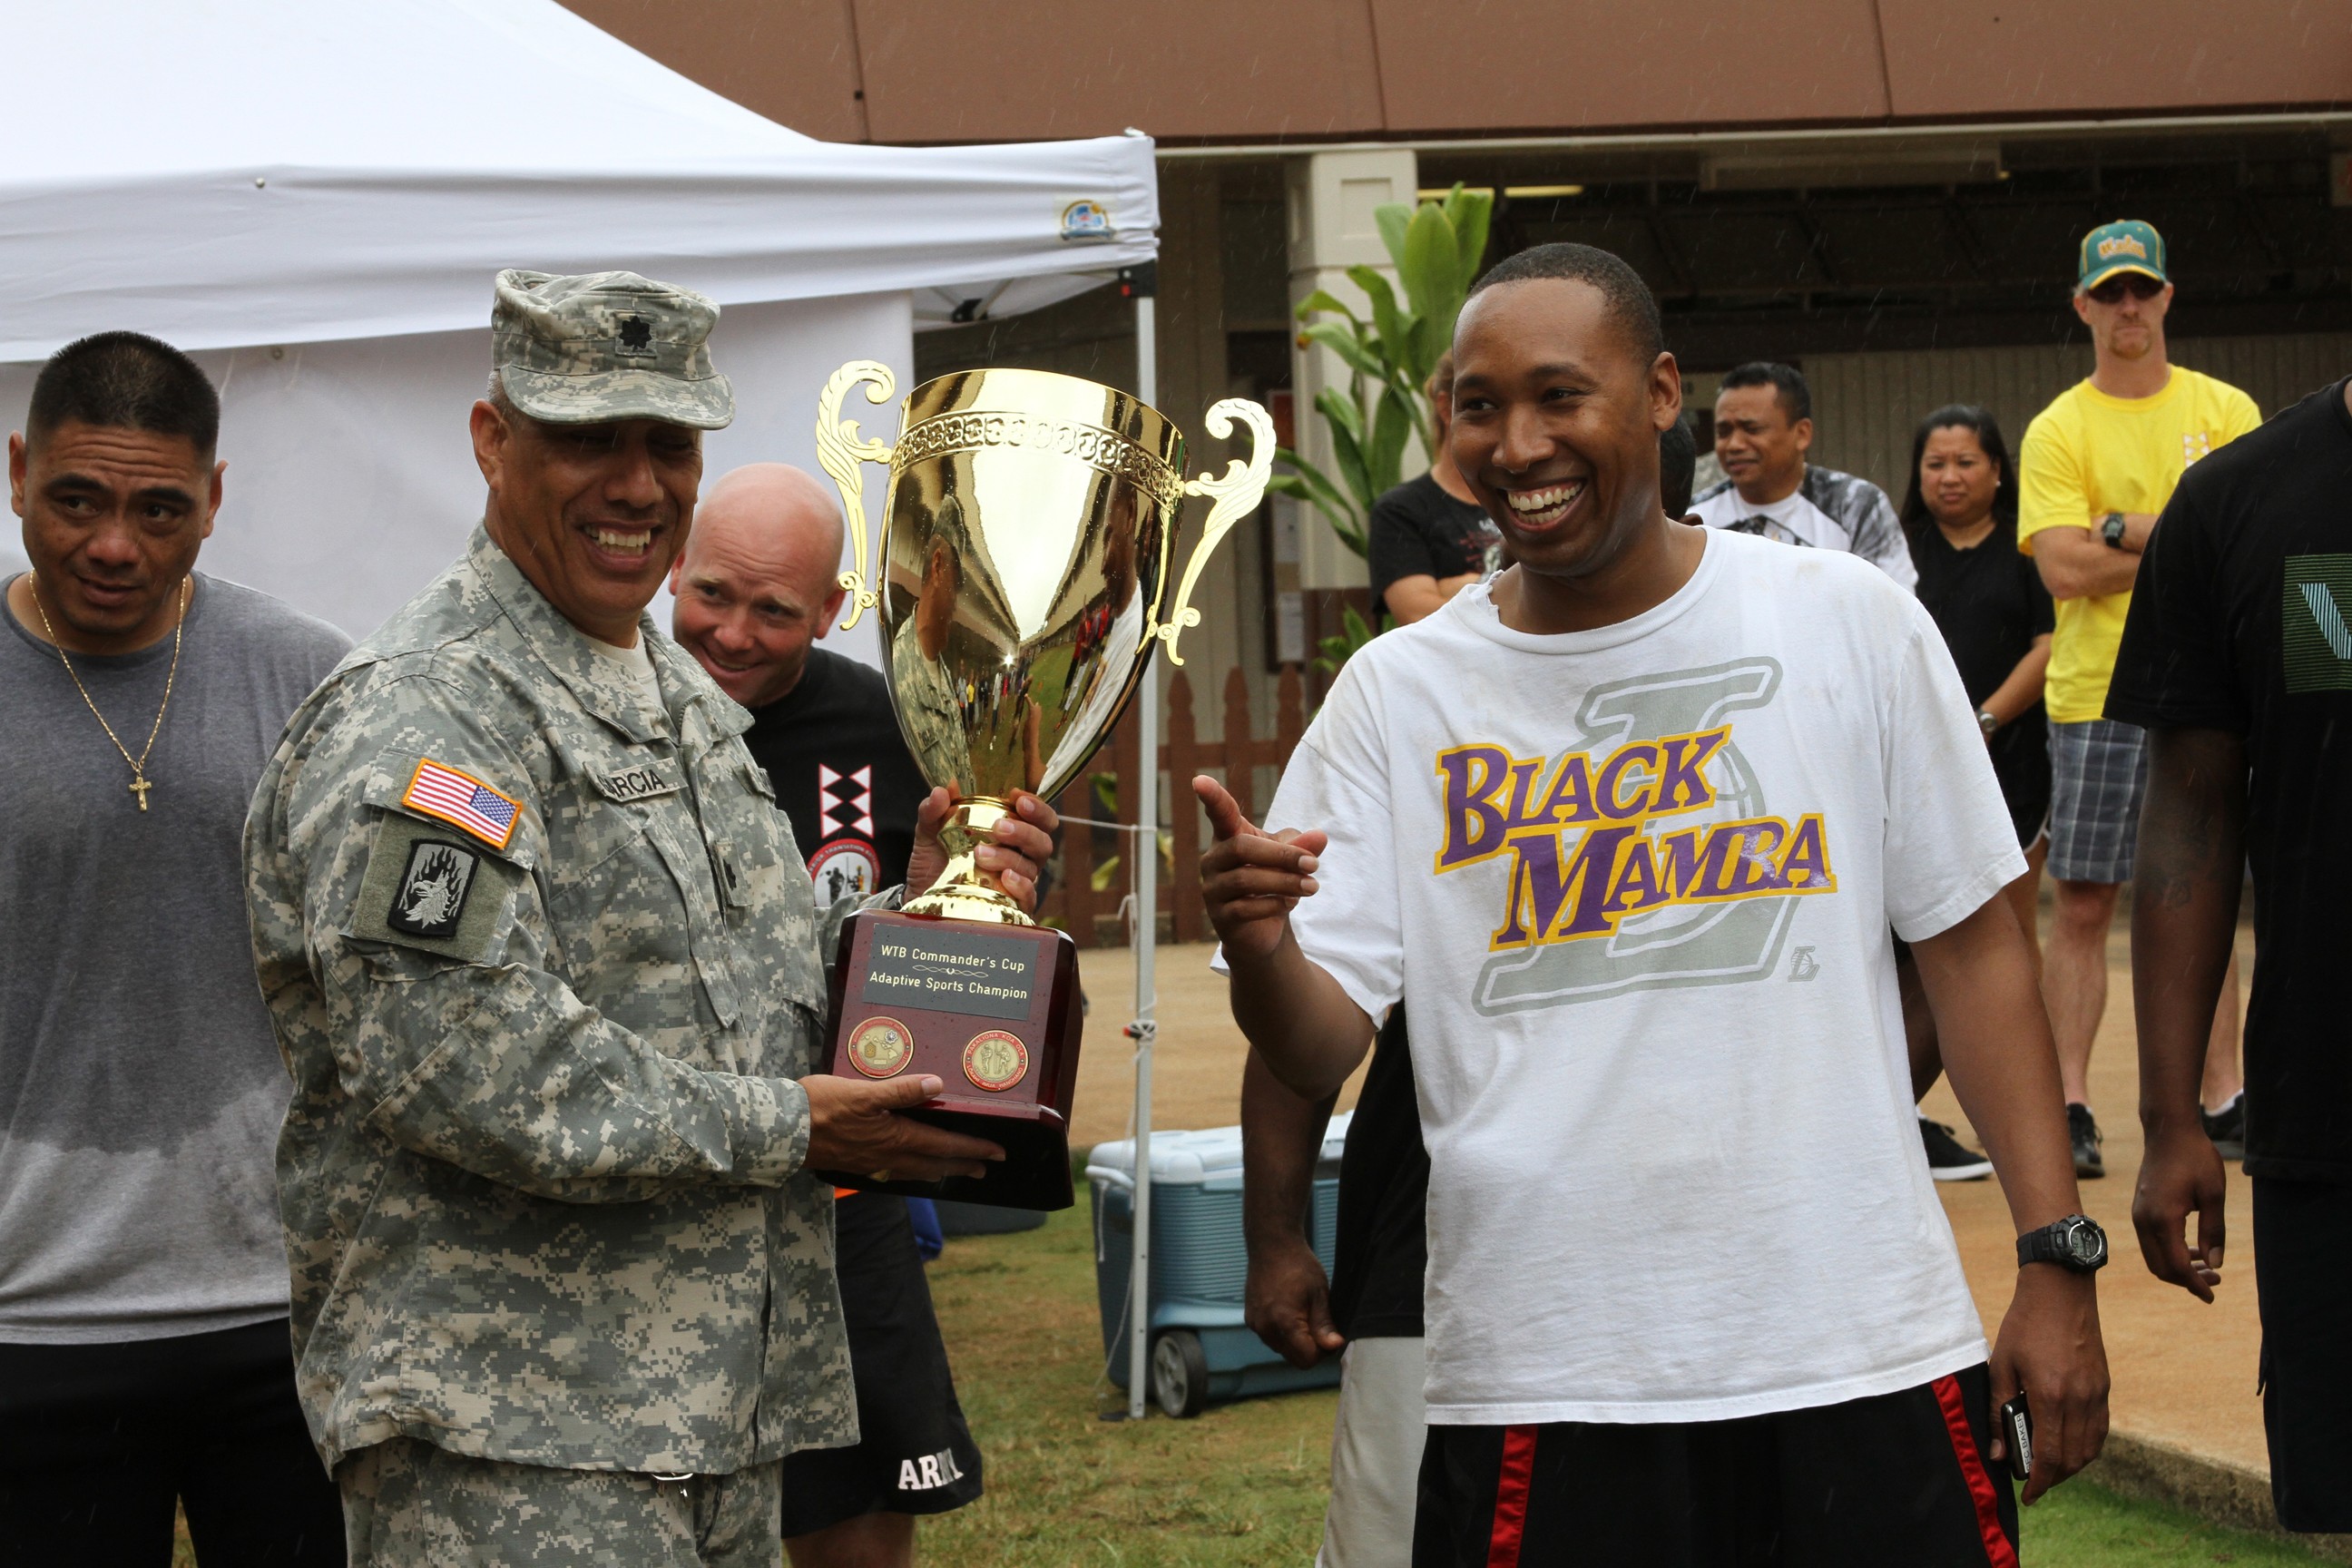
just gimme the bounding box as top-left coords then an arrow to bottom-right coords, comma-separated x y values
2018,219 -> 2263,1175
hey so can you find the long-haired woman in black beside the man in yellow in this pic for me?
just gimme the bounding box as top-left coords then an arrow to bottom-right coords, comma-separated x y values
1896,405 -> 2055,1181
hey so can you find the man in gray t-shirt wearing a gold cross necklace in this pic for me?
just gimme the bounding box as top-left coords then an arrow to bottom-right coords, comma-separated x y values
0,331 -> 350,1563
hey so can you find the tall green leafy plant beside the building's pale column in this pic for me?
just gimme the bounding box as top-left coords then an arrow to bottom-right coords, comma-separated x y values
1268,183 -> 1494,562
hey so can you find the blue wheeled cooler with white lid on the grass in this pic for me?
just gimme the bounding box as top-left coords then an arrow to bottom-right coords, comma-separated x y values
1087,1112 -> 1352,1416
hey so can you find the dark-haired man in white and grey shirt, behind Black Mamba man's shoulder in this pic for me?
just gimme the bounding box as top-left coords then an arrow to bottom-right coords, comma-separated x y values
1693,359 -> 1919,588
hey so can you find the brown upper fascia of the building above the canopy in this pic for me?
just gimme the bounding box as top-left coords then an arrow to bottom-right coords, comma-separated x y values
567,0 -> 2352,143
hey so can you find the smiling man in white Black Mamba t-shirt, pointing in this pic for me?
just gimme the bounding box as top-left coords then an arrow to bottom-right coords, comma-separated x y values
1195,244 -> 2107,1568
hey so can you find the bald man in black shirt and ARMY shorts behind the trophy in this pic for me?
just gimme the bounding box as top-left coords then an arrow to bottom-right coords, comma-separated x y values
671,463 -> 997,1568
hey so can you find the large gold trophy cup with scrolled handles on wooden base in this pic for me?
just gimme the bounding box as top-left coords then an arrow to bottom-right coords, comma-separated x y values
816,359 -> 1275,1209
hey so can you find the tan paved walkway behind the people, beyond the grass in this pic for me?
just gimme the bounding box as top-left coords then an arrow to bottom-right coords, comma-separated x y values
1073,916 -> 2268,1474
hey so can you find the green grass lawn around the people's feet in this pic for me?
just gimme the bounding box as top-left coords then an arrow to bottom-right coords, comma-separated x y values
174,1199 -> 2321,1568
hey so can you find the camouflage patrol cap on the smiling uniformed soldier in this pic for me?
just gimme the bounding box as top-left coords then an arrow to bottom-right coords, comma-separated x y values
489,268 -> 734,430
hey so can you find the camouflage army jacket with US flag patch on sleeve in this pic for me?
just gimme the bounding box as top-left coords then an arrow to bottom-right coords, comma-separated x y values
245,529 -> 856,1474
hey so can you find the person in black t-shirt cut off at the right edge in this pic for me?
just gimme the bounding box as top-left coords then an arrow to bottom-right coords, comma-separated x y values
2107,381 -> 2352,1531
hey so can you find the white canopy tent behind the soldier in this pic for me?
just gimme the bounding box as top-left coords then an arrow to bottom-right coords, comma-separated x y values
0,0 -> 1160,634
